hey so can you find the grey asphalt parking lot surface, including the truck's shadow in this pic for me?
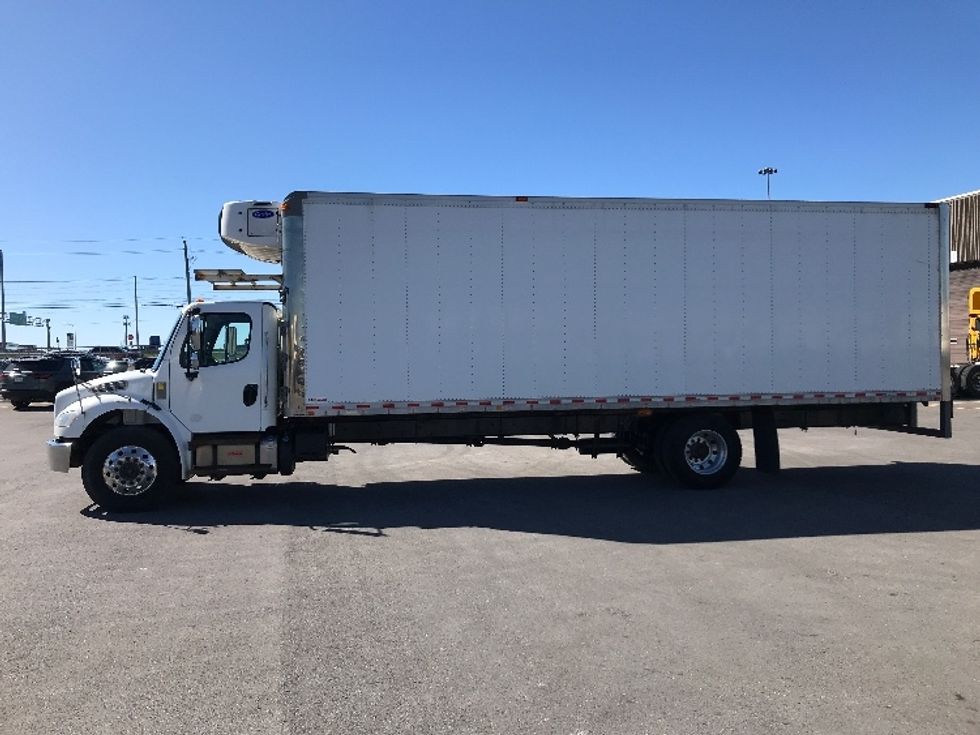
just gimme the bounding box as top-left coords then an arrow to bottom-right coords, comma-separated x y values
0,403 -> 980,735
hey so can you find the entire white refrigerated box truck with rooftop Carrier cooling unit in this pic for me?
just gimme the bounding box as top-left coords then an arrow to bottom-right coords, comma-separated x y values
48,191 -> 952,510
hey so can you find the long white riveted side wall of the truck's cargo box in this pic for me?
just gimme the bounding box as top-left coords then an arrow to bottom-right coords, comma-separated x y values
284,194 -> 941,412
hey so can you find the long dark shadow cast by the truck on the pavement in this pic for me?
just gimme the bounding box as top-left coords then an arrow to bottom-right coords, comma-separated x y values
82,463 -> 980,544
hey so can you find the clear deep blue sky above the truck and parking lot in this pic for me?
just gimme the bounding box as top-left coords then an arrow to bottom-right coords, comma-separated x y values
0,0 -> 980,345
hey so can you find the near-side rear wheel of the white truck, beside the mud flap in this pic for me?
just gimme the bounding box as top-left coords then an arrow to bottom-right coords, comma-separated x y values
659,414 -> 742,490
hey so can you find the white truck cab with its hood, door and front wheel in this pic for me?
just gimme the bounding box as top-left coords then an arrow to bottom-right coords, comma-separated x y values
48,301 -> 279,509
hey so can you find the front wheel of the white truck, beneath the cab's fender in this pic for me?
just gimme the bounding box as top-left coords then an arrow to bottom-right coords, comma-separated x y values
82,427 -> 180,512
